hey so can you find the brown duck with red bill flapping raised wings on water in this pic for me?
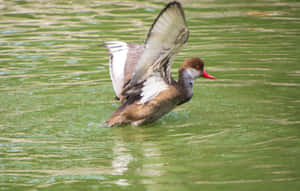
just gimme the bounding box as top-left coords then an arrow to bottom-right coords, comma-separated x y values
104,1 -> 215,127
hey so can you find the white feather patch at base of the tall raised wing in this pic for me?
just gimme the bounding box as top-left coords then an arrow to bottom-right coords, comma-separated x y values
138,73 -> 168,104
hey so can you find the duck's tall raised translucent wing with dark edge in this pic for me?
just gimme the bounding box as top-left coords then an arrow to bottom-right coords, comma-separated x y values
122,1 -> 189,95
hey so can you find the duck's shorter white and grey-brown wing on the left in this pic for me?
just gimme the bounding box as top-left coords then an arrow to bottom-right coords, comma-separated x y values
104,41 -> 144,98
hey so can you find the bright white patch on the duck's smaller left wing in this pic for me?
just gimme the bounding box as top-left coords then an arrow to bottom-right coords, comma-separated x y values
104,41 -> 128,97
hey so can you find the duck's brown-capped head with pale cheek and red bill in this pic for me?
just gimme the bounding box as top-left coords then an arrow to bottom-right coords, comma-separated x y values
179,58 -> 216,80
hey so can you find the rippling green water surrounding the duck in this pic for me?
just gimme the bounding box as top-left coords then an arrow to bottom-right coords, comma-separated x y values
0,0 -> 300,191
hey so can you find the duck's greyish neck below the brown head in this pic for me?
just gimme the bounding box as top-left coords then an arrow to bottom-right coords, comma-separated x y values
178,69 -> 194,103
